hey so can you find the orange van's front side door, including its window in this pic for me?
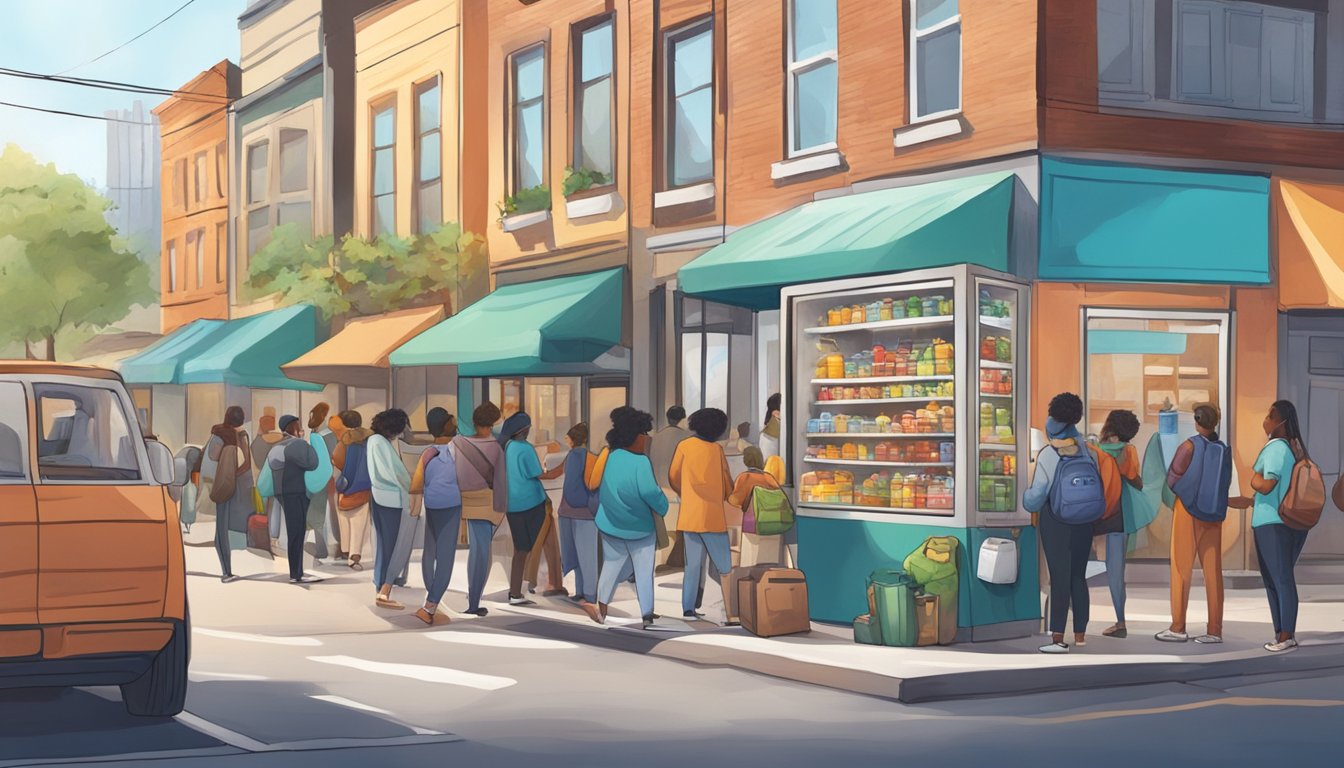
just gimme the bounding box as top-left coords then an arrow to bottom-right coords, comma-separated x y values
32,379 -> 169,624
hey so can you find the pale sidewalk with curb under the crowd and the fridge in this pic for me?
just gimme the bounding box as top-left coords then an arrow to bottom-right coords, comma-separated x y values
187,523 -> 1344,702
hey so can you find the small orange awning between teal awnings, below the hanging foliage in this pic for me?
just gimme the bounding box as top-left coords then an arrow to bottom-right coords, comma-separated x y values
281,307 -> 444,389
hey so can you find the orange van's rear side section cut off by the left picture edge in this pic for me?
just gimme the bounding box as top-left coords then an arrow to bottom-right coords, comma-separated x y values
0,381 -> 38,632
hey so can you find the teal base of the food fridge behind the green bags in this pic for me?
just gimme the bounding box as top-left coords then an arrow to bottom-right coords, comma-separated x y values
797,516 -> 1040,642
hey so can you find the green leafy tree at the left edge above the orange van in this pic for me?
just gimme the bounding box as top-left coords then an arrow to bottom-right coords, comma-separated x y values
0,144 -> 156,360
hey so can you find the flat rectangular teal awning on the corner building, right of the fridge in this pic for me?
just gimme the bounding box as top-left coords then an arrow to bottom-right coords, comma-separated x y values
1038,157 -> 1270,285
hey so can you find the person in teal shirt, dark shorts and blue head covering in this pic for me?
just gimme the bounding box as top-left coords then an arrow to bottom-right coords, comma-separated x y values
500,410 -> 546,605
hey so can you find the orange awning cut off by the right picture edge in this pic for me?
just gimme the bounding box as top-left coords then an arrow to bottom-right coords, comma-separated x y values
1275,180 -> 1344,309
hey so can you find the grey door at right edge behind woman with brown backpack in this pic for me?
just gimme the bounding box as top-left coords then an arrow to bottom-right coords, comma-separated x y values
1278,315 -> 1344,561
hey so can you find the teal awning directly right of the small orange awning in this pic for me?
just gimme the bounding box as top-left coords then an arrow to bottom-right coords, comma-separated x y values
388,269 -> 625,377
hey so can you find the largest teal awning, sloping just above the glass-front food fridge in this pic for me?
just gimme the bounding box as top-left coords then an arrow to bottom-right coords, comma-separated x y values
677,172 -> 1015,309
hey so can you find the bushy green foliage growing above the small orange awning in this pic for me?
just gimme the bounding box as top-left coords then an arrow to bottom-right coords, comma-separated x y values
247,222 -> 487,319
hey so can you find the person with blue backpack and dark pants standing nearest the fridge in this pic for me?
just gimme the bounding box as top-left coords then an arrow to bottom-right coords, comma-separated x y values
1021,393 -> 1106,654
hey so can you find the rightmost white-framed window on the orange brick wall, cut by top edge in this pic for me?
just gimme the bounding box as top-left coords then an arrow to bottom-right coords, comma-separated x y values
910,0 -> 961,121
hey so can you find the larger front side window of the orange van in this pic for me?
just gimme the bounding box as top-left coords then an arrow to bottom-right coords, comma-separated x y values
32,385 -> 140,482
